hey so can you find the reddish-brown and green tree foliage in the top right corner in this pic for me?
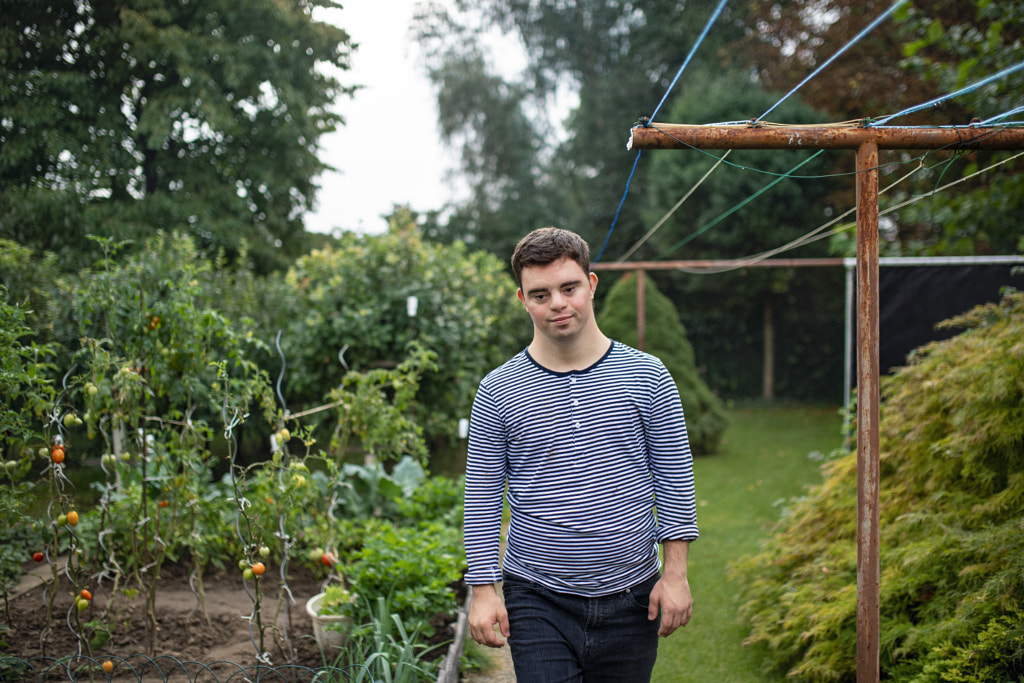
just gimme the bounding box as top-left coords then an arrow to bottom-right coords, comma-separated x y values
743,0 -> 1024,256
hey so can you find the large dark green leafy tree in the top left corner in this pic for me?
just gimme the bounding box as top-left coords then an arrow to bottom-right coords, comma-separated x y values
0,0 -> 351,271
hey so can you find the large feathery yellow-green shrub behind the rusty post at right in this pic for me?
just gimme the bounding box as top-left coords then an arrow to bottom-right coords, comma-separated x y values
733,293 -> 1024,683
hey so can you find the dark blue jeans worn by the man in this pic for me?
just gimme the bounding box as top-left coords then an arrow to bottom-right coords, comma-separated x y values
502,573 -> 660,683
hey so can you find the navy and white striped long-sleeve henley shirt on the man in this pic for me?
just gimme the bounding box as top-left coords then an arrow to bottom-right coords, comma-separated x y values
465,342 -> 697,596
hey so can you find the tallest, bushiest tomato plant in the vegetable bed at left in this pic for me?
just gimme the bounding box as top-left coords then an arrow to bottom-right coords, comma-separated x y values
55,234 -> 269,650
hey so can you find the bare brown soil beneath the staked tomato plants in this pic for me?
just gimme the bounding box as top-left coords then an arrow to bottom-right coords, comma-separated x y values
0,565 -> 454,680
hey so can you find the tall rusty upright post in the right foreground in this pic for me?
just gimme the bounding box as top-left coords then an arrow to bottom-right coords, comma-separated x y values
857,141 -> 881,683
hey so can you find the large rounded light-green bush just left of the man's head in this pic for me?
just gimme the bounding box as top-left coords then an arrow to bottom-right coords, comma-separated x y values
276,212 -> 528,442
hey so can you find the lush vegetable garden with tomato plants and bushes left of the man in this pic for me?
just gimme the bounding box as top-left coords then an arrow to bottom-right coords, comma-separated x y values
0,224 -> 528,680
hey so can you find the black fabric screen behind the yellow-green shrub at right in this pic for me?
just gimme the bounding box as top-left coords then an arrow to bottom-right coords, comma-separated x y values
872,264 -> 1024,374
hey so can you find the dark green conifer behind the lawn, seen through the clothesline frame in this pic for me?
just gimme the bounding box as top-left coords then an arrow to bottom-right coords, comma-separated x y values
632,70 -> 854,400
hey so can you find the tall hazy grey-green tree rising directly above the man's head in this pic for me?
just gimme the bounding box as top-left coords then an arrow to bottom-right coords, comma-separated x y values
420,0 -> 739,256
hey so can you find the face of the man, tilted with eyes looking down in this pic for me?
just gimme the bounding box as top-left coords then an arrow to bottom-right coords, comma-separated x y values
517,258 -> 597,341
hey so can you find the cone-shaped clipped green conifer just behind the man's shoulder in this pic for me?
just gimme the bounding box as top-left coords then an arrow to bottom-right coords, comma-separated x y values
598,273 -> 727,455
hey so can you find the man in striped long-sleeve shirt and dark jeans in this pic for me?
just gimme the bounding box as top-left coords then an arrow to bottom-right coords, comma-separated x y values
465,227 -> 697,683
